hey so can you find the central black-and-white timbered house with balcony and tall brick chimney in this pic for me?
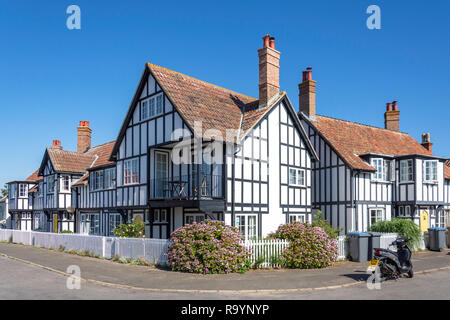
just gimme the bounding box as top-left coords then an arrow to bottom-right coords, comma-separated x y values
101,35 -> 317,238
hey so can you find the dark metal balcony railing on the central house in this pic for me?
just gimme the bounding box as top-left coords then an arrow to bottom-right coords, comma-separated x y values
150,174 -> 223,200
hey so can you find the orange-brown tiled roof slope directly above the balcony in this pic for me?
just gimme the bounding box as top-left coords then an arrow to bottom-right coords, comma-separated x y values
147,63 -> 258,142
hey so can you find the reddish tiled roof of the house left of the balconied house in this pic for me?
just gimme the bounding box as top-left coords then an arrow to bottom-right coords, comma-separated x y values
47,141 -> 115,173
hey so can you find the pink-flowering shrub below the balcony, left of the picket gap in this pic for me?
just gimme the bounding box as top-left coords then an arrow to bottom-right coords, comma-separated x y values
168,220 -> 250,274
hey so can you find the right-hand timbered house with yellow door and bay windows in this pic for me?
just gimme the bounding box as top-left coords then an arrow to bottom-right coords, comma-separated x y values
298,68 -> 450,233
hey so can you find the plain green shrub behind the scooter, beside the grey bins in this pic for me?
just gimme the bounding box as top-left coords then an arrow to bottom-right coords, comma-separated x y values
369,218 -> 422,250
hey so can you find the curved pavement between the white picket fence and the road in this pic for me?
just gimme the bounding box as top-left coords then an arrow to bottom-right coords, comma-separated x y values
0,243 -> 450,294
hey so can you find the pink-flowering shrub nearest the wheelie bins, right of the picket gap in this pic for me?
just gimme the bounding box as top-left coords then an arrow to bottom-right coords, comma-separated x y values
270,222 -> 338,269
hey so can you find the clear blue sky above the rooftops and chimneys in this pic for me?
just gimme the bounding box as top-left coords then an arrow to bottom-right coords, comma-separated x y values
0,0 -> 450,186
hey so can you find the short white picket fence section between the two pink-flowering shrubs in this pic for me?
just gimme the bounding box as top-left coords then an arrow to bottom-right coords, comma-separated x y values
242,240 -> 289,268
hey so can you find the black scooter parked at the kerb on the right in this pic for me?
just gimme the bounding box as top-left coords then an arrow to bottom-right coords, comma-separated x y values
368,239 -> 414,281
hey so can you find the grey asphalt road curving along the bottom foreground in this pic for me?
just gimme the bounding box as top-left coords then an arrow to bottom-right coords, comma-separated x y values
0,257 -> 450,300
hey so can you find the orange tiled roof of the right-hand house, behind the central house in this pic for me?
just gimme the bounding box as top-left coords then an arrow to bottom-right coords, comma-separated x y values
310,116 -> 433,171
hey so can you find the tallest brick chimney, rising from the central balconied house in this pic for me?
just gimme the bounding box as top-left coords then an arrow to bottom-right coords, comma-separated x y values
258,34 -> 281,107
